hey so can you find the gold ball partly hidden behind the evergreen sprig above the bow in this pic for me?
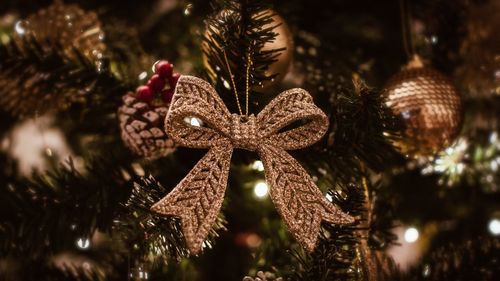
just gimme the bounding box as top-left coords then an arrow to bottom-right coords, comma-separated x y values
202,9 -> 294,91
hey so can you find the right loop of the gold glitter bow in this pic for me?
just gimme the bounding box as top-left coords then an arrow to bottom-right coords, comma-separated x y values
257,88 -> 328,150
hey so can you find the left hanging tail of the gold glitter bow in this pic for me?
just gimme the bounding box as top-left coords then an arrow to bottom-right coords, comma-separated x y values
151,143 -> 233,254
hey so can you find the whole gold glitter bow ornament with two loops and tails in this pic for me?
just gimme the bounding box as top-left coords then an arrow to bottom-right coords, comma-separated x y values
151,76 -> 353,254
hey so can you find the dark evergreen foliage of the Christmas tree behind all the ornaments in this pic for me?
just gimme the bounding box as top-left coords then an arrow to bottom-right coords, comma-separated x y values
0,0 -> 500,281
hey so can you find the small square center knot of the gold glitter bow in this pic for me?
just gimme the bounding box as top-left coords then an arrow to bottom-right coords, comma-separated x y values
231,114 -> 258,151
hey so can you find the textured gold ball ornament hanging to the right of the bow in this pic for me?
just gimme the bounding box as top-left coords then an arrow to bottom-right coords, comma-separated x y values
383,56 -> 462,157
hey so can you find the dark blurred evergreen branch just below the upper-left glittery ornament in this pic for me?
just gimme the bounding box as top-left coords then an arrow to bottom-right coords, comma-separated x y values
0,36 -> 131,117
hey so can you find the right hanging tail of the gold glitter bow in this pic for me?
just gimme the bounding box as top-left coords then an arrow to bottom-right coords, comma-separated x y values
259,145 -> 354,251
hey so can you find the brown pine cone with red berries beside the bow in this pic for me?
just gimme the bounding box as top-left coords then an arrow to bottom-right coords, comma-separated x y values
118,61 -> 179,160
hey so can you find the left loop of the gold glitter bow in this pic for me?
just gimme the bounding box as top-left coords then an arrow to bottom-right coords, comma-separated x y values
165,76 -> 231,148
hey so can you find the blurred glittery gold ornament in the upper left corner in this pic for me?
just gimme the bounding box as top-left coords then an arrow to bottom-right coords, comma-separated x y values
13,0 -> 106,63
